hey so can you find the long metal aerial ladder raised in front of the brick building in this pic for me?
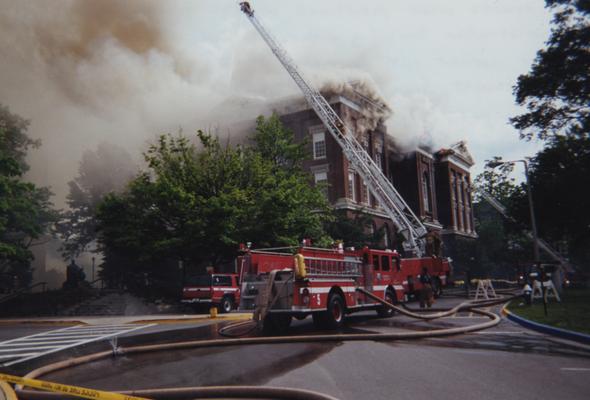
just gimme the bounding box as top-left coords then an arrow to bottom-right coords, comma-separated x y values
240,1 -> 427,257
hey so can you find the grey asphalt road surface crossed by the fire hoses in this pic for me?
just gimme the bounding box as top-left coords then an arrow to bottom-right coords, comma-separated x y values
4,300 -> 590,400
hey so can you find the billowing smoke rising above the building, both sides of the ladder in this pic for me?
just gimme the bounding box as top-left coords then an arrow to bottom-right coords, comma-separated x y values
0,0 -> 462,207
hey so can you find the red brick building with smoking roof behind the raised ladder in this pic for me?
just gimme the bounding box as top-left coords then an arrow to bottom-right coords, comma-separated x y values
275,89 -> 476,257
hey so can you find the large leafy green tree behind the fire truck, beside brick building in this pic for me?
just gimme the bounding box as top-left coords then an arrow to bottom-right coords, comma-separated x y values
97,115 -> 327,292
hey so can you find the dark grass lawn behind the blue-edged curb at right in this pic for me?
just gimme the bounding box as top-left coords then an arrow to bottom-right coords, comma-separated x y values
508,289 -> 590,334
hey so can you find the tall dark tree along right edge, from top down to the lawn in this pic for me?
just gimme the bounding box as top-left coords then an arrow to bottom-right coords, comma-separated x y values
511,0 -> 590,266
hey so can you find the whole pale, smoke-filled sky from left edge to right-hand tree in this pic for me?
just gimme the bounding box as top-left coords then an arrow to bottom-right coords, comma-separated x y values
0,0 -> 551,207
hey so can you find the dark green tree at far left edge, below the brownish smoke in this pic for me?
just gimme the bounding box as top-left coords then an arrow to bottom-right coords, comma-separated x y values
0,105 -> 55,287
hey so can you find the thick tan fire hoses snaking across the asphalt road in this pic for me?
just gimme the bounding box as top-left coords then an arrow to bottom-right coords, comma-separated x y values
10,288 -> 517,400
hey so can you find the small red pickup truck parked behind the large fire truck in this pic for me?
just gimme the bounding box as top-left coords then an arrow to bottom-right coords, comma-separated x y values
181,274 -> 240,313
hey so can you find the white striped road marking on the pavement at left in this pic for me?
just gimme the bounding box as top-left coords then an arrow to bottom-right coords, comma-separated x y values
0,324 -> 156,367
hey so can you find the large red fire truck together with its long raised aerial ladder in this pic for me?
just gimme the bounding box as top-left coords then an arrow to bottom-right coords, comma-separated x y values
237,2 -> 450,330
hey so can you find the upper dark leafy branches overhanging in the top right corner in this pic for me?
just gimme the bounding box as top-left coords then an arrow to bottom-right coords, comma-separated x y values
511,0 -> 590,140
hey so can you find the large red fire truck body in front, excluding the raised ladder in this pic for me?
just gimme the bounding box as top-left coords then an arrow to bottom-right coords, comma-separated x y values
237,247 -> 450,331
